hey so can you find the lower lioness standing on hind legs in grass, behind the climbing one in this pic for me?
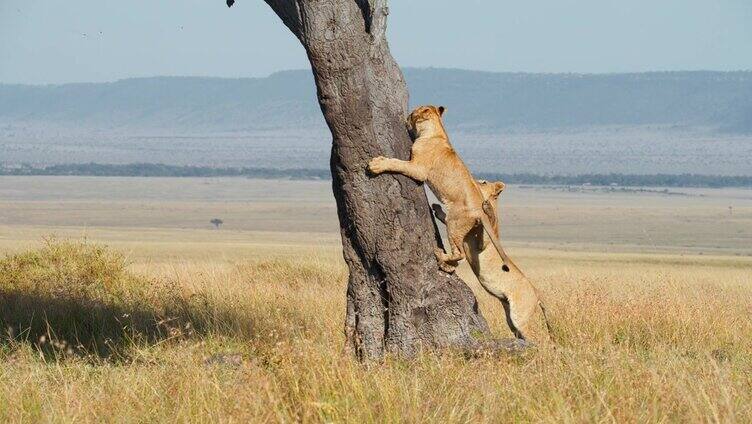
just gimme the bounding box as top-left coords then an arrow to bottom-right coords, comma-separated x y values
432,180 -> 551,339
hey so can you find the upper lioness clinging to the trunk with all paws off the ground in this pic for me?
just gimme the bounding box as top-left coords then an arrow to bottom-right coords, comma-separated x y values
368,106 -> 508,273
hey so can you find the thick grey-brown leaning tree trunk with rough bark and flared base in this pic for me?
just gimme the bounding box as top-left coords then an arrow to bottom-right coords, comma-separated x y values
266,0 -> 489,360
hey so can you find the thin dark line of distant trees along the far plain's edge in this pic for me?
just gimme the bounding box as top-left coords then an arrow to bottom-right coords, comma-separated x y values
0,163 -> 752,188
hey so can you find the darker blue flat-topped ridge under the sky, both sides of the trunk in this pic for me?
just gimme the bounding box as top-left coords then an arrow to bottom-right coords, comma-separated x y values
0,68 -> 752,134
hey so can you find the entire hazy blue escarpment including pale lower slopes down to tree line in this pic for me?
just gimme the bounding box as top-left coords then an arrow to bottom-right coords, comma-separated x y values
0,68 -> 752,176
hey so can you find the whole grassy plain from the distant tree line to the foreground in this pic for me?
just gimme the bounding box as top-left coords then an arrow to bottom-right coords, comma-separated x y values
0,177 -> 752,422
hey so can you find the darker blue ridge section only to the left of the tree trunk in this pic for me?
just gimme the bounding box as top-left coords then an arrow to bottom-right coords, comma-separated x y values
0,71 -> 322,132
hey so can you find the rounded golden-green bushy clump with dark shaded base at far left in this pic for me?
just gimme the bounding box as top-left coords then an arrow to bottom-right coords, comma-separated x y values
0,240 -> 205,356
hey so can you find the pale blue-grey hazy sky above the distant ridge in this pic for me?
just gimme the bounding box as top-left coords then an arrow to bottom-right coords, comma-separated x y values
0,0 -> 752,84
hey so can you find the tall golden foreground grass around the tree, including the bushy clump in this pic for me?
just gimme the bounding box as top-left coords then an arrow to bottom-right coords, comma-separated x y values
0,241 -> 752,422
